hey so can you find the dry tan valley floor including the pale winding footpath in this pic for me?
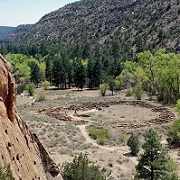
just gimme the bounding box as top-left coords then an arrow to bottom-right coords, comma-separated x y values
17,89 -> 179,180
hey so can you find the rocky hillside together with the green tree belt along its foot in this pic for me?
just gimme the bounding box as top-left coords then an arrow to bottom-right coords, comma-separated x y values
0,0 -> 180,103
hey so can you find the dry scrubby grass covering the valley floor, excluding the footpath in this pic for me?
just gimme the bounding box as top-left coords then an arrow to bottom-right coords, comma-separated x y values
17,88 -> 179,180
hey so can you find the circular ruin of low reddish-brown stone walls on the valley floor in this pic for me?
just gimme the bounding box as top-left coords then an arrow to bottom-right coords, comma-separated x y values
39,101 -> 175,128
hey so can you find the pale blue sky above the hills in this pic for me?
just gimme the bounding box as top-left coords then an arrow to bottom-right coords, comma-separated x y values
0,0 -> 78,27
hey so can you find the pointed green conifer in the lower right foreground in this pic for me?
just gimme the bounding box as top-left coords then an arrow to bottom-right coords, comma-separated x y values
135,129 -> 176,180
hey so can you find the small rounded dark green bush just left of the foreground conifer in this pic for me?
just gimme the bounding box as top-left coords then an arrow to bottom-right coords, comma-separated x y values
127,133 -> 141,156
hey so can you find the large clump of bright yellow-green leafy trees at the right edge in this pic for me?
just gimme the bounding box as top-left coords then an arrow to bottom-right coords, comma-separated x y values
120,49 -> 180,104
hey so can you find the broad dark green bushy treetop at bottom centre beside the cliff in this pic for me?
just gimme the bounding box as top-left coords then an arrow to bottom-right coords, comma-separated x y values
61,153 -> 109,180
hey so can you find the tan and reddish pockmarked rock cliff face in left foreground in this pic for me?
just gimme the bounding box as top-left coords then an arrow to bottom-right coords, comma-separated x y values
0,55 -> 61,180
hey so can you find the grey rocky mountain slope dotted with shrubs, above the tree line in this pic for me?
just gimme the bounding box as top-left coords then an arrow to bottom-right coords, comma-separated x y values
1,0 -> 180,56
